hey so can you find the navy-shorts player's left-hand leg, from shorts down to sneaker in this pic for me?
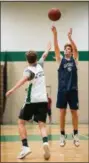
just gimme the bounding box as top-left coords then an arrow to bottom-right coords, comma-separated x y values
57,92 -> 67,147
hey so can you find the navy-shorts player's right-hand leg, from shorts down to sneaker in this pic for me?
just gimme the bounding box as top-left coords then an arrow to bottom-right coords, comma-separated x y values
69,91 -> 80,146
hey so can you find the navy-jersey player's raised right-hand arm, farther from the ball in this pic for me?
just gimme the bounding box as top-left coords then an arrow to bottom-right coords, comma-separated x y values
68,28 -> 78,59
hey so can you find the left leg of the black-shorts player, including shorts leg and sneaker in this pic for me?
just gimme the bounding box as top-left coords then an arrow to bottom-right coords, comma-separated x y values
18,104 -> 32,159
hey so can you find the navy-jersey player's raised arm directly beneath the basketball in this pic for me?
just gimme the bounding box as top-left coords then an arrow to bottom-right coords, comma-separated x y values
52,26 -> 61,61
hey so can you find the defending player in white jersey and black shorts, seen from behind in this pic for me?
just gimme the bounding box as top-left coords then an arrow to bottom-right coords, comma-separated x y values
6,43 -> 51,159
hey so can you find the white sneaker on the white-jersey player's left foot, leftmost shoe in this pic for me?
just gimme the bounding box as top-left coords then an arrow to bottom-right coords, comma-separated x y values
17,146 -> 31,159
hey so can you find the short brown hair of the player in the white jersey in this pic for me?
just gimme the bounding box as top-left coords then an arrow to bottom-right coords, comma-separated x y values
26,50 -> 37,63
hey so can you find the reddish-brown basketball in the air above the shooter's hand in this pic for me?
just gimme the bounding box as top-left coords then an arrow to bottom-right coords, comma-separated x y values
48,8 -> 61,21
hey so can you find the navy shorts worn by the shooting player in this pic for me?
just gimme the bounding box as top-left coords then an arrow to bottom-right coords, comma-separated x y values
56,90 -> 79,110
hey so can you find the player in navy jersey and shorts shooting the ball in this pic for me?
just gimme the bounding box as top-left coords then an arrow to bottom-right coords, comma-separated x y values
52,26 -> 79,146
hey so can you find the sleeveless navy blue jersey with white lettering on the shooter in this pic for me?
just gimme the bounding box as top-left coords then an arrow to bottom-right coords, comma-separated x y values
58,57 -> 78,91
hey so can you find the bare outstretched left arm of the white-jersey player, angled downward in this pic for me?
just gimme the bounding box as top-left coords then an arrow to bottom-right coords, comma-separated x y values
6,77 -> 28,96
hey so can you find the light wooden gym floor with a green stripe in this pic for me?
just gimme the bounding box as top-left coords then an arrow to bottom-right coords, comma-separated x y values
1,125 -> 89,162
